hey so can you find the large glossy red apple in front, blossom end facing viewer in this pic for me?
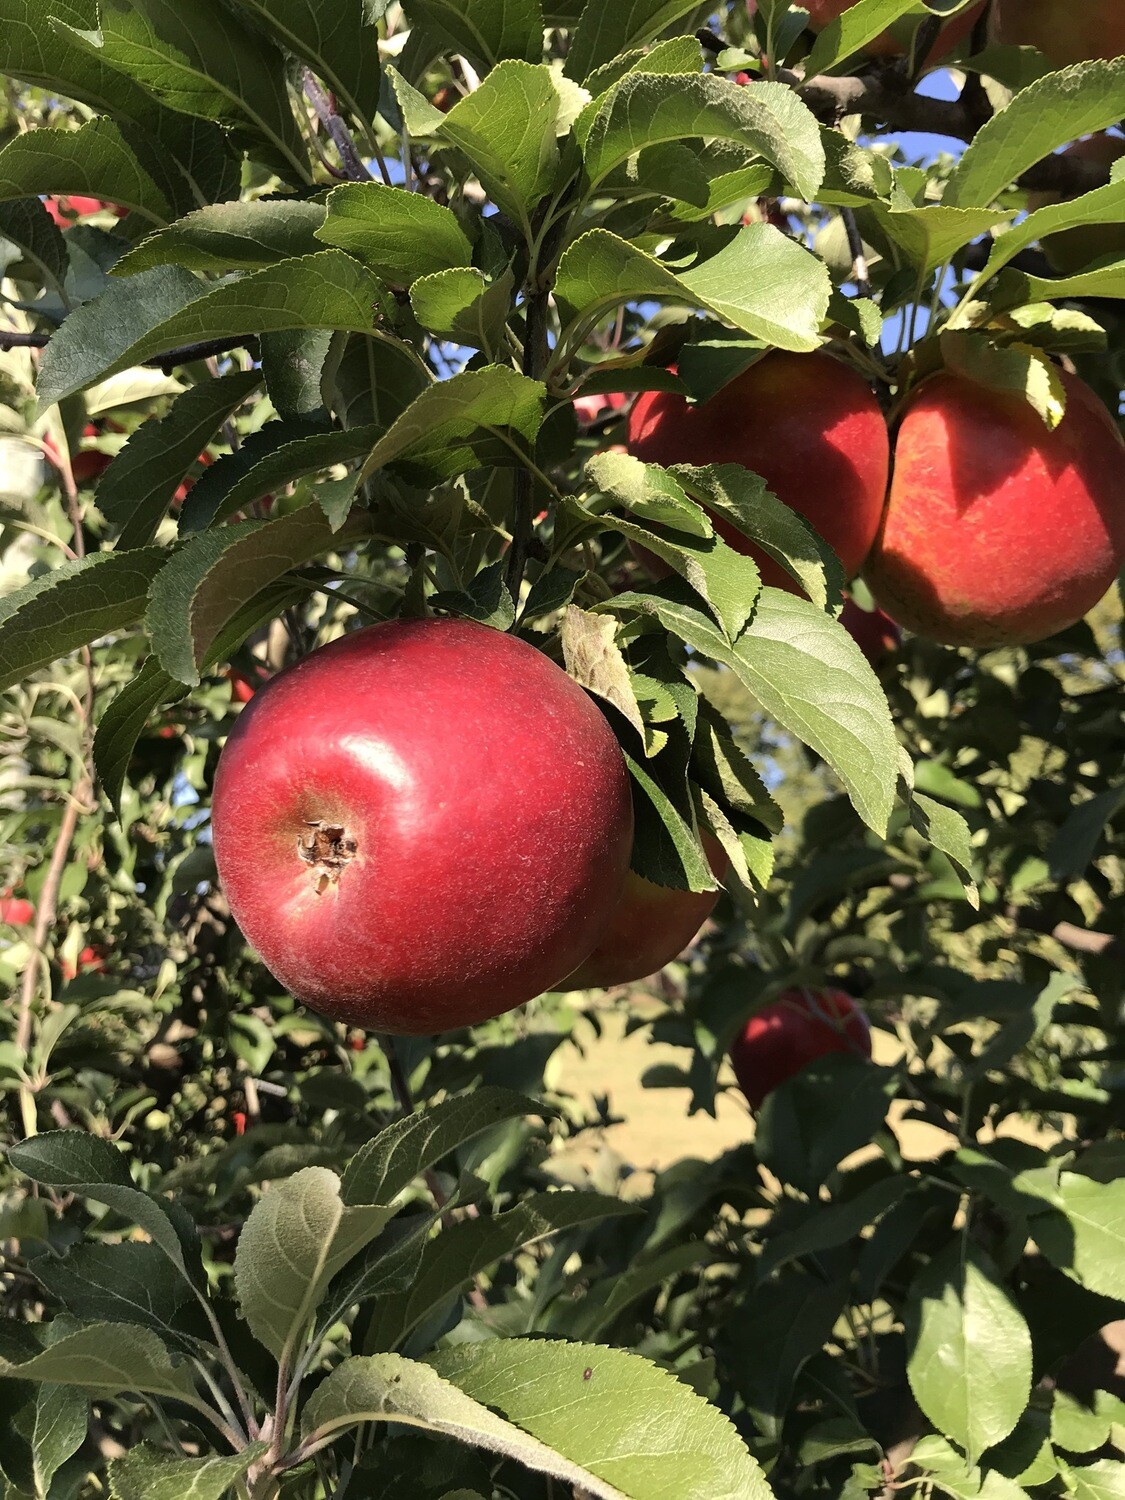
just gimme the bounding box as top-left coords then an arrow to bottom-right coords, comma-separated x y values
213,620 -> 633,1035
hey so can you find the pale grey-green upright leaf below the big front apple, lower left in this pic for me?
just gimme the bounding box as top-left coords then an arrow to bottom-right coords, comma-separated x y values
234,1167 -> 393,1359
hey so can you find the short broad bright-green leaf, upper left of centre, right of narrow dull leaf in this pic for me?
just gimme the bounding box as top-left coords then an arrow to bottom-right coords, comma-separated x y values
317,183 -> 473,287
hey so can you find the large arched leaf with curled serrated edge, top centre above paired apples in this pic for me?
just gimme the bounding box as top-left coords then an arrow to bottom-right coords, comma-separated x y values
582,74 -> 825,201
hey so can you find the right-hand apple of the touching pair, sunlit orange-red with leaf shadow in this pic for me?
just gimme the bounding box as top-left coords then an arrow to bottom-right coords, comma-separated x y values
864,372 -> 1125,647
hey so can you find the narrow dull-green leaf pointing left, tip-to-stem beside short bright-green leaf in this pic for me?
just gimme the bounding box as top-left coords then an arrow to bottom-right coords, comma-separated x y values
113,198 -> 324,276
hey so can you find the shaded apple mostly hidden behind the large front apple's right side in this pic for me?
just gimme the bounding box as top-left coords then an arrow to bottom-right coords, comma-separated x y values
563,833 -> 726,990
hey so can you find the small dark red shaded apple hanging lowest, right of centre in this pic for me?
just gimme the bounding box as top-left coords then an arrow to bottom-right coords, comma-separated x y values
731,990 -> 872,1110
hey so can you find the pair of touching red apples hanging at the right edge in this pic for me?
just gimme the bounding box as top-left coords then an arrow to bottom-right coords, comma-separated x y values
627,351 -> 1125,647
